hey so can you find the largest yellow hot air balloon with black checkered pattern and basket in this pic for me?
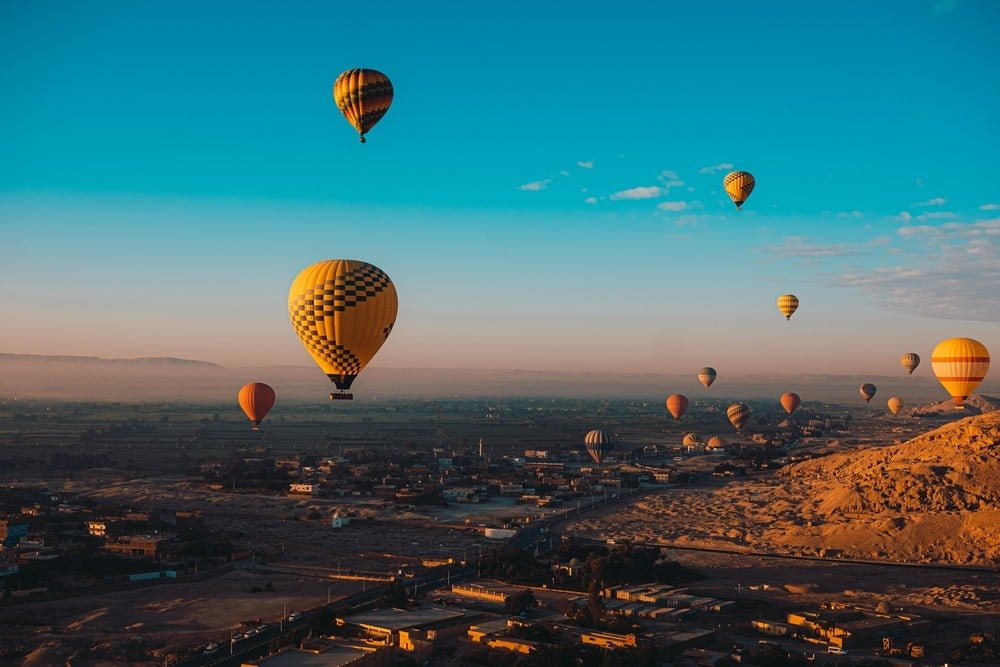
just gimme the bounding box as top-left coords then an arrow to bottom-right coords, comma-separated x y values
288,259 -> 399,399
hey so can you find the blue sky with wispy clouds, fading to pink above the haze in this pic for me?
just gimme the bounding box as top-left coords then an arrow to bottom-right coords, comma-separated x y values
0,0 -> 1000,372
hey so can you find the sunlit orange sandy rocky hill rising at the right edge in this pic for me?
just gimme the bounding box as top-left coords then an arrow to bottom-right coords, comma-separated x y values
567,411 -> 1000,565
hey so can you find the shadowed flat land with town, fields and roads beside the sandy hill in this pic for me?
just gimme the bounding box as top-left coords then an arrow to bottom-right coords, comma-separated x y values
0,399 -> 998,666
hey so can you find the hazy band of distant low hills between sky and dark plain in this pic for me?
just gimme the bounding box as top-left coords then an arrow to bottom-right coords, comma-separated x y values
0,353 -> 1000,409
